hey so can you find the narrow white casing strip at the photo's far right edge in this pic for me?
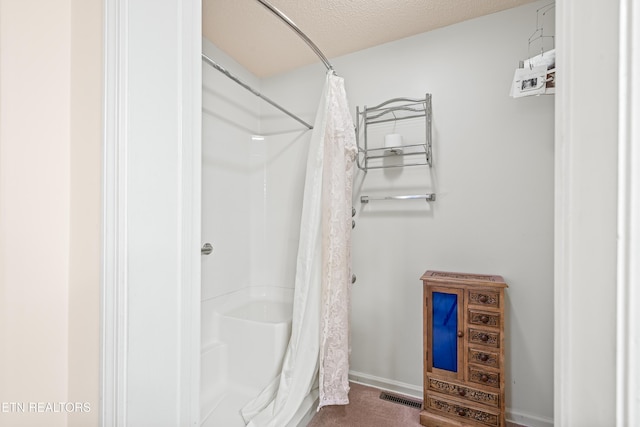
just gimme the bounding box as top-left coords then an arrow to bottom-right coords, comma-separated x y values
616,0 -> 640,427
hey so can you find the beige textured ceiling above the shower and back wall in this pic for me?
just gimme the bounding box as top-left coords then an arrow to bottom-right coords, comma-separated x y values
202,0 -> 533,77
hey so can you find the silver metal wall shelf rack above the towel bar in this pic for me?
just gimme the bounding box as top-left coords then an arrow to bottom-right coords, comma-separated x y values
356,93 -> 432,172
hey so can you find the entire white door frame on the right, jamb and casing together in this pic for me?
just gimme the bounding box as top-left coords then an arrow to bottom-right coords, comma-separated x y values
554,0 -> 640,427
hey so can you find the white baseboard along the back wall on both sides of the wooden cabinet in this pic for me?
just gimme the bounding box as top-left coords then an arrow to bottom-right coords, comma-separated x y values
349,370 -> 553,427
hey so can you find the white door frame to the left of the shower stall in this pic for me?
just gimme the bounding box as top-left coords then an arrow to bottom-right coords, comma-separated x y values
100,0 -> 202,427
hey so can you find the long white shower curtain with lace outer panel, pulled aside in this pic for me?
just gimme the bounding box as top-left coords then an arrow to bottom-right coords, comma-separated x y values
242,71 -> 356,427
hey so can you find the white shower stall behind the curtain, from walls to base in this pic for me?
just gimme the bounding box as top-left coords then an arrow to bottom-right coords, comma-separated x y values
200,2 -> 336,427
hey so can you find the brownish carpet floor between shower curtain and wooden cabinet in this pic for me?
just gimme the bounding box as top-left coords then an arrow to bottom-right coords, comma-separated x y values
307,383 -> 420,427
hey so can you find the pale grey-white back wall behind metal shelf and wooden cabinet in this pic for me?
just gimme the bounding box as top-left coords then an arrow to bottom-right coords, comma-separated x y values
262,2 -> 554,425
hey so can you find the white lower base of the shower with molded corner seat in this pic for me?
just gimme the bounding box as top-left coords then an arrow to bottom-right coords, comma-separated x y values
200,286 -> 317,427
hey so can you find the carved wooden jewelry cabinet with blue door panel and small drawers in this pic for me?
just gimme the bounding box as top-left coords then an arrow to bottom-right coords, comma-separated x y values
420,271 -> 507,427
